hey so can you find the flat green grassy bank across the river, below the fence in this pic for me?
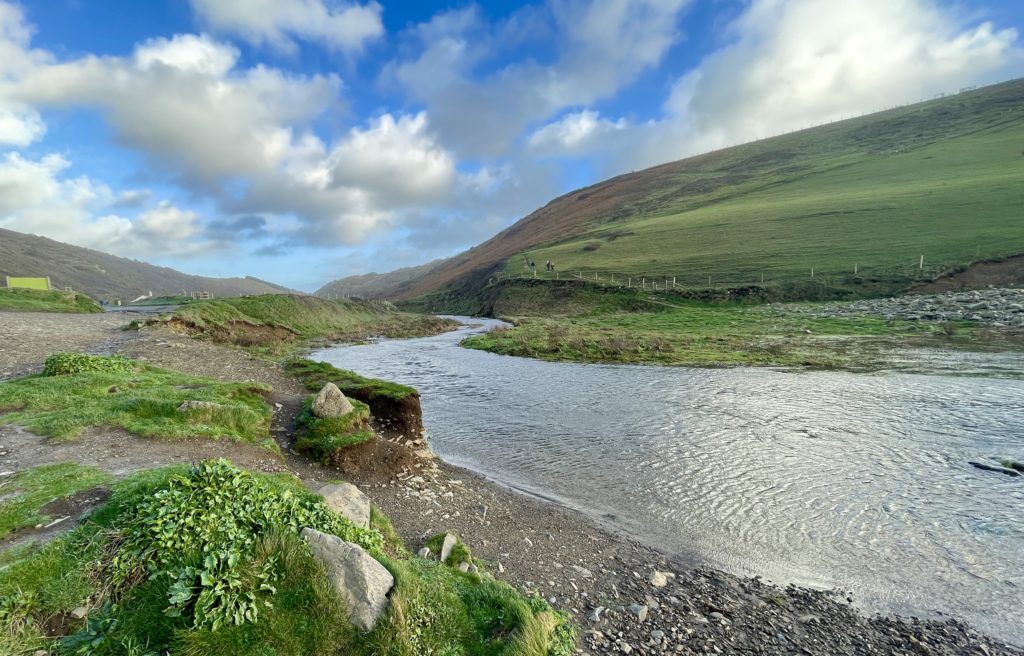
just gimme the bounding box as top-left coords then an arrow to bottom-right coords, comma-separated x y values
462,296 -> 975,368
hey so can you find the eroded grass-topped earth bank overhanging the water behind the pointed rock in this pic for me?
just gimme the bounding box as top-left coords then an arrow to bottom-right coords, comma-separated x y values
288,359 -> 423,439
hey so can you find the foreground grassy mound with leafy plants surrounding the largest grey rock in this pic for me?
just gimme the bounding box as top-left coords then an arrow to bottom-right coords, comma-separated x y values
0,461 -> 573,656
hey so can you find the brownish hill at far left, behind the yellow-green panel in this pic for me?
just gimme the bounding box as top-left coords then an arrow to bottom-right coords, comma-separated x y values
0,229 -> 295,301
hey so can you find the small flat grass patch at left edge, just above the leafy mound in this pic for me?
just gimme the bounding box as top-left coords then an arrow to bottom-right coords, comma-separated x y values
0,463 -> 111,538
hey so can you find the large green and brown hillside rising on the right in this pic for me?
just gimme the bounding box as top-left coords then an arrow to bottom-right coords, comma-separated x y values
323,80 -> 1024,299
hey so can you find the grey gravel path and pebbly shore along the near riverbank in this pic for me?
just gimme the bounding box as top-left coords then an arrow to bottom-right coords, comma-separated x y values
0,315 -> 1024,656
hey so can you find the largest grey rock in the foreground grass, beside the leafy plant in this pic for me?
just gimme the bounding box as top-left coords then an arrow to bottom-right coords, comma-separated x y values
302,528 -> 394,631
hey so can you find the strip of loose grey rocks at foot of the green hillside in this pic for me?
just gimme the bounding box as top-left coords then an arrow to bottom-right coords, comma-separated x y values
777,289 -> 1024,327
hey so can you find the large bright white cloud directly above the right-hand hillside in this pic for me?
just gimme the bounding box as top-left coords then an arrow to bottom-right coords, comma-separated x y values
647,0 -> 1021,163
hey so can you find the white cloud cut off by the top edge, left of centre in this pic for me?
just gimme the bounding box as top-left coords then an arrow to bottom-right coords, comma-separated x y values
190,0 -> 384,53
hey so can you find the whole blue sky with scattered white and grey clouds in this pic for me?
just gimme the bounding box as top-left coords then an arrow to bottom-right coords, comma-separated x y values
0,0 -> 1024,291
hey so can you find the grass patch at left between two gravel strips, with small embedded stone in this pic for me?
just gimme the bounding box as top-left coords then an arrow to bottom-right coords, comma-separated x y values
0,353 -> 274,448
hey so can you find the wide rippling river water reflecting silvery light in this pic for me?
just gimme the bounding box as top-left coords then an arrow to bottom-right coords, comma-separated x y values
310,317 -> 1024,644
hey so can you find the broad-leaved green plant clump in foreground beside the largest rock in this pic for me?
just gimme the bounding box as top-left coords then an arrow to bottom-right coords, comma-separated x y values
111,460 -> 384,629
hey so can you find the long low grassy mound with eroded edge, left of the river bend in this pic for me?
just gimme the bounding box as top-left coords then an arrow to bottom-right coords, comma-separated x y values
168,294 -> 452,351
